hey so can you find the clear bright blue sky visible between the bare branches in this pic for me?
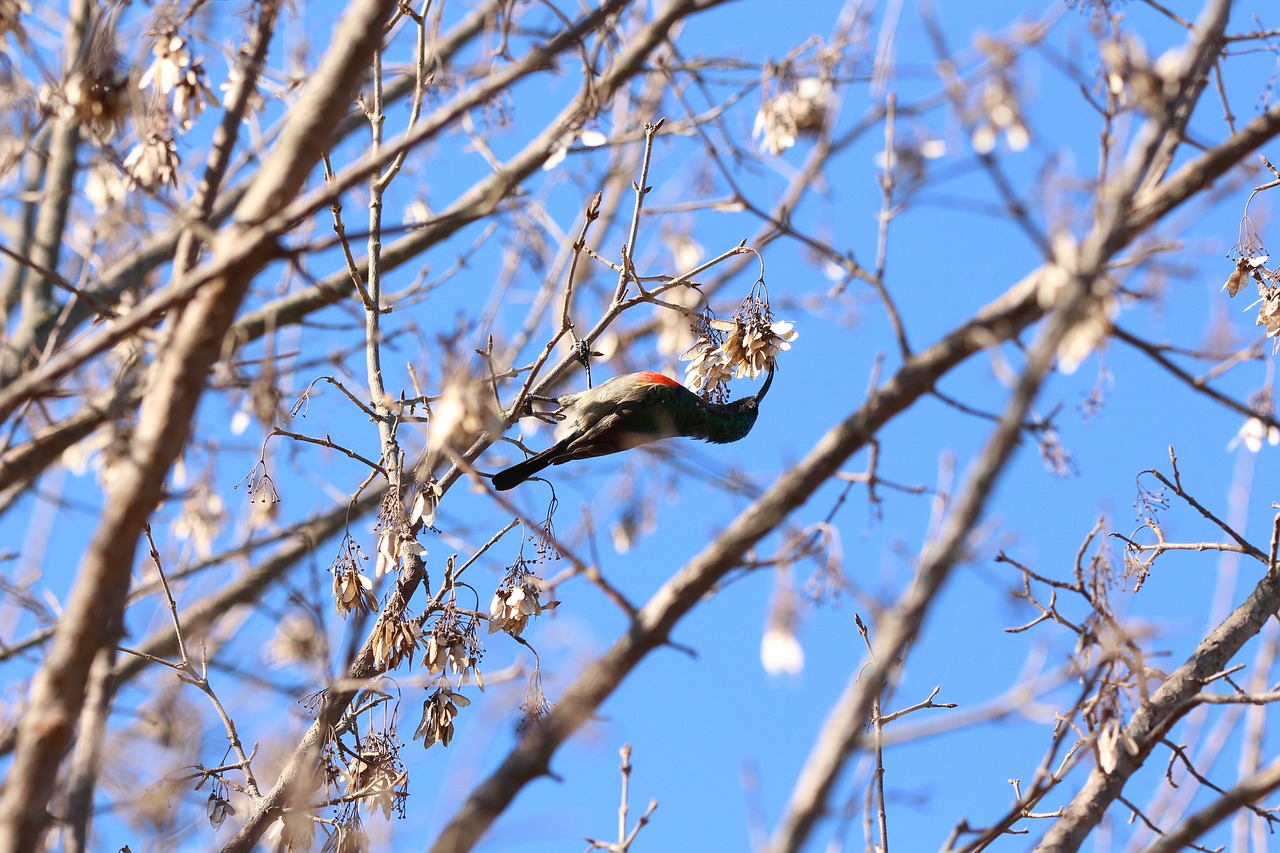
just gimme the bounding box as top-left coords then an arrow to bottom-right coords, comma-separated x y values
0,0 -> 1280,850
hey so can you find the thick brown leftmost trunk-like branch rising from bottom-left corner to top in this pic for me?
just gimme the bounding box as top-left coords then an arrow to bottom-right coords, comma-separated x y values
0,0 -> 396,850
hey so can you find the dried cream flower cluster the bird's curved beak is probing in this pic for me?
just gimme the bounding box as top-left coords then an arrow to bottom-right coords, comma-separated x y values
680,282 -> 800,402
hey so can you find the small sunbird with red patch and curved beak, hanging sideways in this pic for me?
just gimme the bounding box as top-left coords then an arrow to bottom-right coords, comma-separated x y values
493,365 -> 773,492
